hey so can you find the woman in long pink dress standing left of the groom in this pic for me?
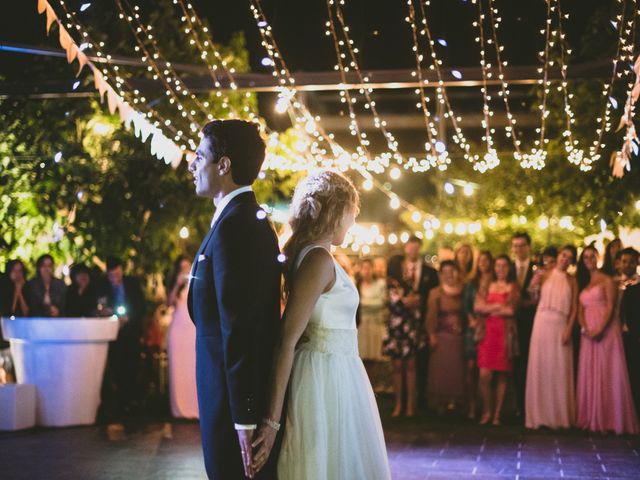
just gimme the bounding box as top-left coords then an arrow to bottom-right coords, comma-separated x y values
167,257 -> 199,418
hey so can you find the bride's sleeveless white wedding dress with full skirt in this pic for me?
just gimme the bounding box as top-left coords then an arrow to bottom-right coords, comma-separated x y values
278,245 -> 391,480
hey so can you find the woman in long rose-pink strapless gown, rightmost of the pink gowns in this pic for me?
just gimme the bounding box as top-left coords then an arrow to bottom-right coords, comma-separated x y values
576,246 -> 638,434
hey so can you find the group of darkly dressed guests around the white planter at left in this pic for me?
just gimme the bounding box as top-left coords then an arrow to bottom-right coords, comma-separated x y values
0,254 -> 146,420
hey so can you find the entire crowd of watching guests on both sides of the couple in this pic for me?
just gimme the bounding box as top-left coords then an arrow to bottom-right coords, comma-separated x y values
0,233 -> 640,434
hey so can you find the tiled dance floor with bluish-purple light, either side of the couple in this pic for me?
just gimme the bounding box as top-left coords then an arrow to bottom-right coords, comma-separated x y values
0,408 -> 640,480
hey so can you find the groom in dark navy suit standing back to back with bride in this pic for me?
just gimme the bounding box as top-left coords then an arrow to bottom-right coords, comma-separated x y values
188,120 -> 281,480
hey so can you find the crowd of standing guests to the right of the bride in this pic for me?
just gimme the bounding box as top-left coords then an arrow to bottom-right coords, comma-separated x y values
352,232 -> 640,434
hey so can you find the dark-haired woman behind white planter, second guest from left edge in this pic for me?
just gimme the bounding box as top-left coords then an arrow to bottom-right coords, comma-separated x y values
27,254 -> 67,317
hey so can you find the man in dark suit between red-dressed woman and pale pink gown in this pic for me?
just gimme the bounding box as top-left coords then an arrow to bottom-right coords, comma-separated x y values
511,232 -> 536,415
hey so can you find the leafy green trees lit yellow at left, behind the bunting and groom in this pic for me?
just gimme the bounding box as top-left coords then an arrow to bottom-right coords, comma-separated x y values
0,0 -> 294,273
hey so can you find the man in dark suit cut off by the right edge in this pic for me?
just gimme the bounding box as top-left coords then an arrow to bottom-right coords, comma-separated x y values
620,248 -> 640,412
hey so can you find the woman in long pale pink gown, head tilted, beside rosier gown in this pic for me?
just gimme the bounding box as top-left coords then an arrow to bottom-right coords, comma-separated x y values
525,245 -> 578,428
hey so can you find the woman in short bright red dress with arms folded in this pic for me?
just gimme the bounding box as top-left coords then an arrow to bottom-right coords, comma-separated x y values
475,255 -> 520,425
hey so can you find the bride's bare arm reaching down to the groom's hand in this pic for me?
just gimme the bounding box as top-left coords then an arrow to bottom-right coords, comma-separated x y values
253,248 -> 336,470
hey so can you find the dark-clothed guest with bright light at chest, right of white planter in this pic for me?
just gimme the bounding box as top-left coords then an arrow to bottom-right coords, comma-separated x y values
97,257 -> 145,420
